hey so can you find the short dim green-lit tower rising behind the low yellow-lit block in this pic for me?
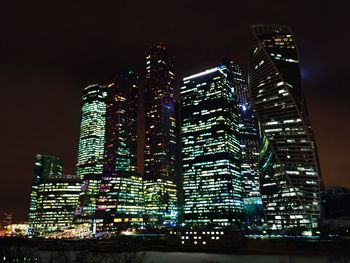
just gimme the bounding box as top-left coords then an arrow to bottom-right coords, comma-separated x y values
28,154 -> 62,235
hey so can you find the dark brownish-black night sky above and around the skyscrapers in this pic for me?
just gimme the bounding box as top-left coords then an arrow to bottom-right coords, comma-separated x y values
0,0 -> 350,220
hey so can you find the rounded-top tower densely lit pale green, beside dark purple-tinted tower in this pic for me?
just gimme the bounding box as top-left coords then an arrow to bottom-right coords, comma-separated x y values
75,84 -> 107,229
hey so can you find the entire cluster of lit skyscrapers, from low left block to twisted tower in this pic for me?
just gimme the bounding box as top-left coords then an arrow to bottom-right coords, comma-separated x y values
29,25 -> 320,237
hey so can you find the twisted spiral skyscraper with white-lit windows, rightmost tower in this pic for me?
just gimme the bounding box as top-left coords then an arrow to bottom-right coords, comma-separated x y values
249,25 -> 320,229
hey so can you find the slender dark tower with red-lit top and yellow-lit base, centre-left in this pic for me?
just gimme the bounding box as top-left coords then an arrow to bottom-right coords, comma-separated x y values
143,44 -> 177,226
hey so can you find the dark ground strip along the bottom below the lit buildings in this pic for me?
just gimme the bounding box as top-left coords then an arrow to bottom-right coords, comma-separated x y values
0,237 -> 350,263
